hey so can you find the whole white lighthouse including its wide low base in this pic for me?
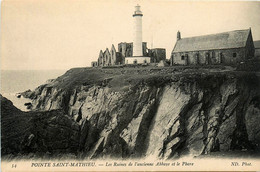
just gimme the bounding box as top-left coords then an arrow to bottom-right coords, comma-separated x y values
125,5 -> 150,64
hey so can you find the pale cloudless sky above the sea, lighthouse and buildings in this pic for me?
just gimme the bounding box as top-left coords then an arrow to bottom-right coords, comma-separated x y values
0,0 -> 260,70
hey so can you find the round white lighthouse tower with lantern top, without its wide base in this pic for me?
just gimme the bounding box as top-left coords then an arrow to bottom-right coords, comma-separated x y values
133,5 -> 143,56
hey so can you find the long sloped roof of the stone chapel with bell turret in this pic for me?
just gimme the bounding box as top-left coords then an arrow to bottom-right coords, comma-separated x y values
173,29 -> 250,52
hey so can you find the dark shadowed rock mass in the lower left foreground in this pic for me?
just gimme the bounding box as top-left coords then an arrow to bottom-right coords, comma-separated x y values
0,96 -> 79,158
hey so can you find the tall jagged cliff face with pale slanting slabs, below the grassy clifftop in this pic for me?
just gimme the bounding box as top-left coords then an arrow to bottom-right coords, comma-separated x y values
16,68 -> 260,159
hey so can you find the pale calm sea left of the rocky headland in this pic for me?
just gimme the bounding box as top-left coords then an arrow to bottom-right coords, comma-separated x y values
0,70 -> 66,111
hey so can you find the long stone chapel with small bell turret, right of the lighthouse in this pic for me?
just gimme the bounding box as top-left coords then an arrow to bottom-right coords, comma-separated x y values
171,29 -> 255,65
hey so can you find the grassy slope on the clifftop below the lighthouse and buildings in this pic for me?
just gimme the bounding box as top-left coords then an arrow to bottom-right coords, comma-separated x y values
49,66 -> 236,90
